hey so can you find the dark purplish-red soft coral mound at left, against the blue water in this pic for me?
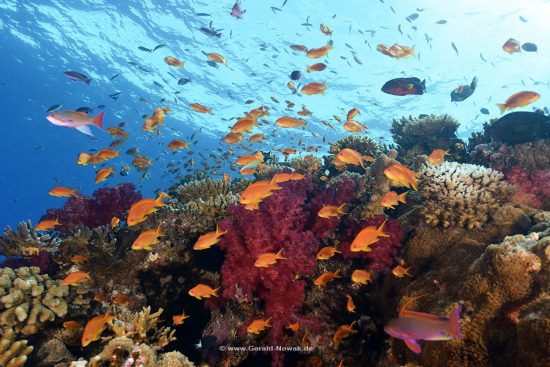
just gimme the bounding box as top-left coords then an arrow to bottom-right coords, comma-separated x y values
47,183 -> 141,232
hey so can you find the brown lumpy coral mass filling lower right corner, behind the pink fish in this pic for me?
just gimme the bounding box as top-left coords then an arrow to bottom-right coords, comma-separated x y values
385,214 -> 550,367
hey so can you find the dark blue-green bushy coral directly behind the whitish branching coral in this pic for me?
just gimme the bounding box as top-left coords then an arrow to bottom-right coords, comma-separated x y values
390,115 -> 466,165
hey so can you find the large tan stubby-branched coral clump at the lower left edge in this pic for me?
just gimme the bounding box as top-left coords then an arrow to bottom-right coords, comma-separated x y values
0,267 -> 69,335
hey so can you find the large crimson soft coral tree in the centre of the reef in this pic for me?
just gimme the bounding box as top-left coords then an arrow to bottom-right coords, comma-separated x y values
219,177 -> 355,366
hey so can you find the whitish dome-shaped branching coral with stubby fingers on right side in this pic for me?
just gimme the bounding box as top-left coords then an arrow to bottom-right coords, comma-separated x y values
419,162 -> 513,229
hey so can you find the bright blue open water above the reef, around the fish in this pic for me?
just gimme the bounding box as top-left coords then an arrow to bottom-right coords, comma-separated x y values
0,0 -> 550,230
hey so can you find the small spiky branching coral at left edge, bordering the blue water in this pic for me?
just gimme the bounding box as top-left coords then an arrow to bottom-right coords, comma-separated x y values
0,221 -> 59,256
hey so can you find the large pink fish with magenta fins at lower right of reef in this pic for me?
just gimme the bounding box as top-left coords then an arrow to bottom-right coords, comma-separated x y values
384,304 -> 460,354
